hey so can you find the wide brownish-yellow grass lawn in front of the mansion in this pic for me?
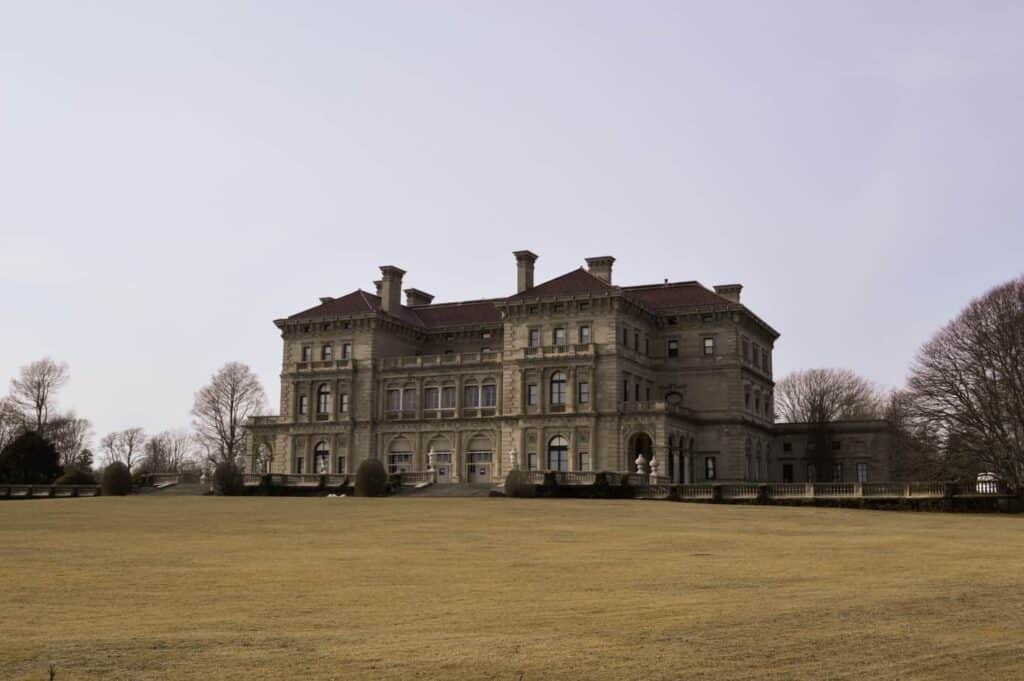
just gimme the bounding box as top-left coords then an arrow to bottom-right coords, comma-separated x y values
0,497 -> 1024,681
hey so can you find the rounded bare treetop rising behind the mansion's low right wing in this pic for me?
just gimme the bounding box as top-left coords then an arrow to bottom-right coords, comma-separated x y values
775,369 -> 884,424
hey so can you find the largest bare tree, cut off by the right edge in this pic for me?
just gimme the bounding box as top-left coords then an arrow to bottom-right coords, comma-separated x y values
907,276 -> 1024,488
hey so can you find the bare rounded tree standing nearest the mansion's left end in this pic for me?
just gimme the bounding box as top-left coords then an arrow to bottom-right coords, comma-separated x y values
191,361 -> 266,463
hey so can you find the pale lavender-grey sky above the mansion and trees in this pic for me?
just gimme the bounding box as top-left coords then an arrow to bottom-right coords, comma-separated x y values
0,0 -> 1024,439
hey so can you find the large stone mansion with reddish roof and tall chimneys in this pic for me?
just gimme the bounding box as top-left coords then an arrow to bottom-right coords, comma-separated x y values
247,251 -> 888,482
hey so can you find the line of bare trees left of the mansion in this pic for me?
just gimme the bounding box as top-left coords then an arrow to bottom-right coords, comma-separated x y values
0,357 -> 266,484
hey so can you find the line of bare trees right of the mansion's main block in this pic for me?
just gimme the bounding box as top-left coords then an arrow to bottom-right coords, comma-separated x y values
775,276 -> 1024,490
